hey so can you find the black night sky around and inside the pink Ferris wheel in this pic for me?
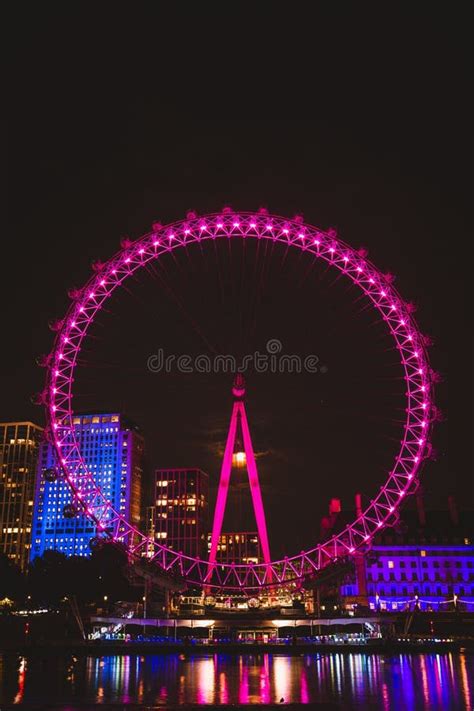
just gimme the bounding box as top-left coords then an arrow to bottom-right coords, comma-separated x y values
0,3 -> 473,554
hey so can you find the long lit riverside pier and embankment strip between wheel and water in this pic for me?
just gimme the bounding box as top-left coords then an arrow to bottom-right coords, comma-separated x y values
88,609 -> 474,646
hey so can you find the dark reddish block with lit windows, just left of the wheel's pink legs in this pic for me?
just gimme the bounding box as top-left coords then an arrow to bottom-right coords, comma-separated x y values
151,469 -> 209,558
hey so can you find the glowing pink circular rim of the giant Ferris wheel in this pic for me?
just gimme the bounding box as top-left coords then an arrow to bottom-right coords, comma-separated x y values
43,210 -> 435,592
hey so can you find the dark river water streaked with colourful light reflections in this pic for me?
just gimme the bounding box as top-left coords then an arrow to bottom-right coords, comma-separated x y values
0,653 -> 474,711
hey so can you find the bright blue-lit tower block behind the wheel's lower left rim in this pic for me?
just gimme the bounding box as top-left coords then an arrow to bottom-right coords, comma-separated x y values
31,412 -> 144,560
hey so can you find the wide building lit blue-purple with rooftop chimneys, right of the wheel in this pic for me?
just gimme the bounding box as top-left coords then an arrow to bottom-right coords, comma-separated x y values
323,495 -> 474,611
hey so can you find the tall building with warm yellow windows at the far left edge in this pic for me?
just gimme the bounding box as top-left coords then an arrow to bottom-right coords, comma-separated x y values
0,422 -> 43,570
